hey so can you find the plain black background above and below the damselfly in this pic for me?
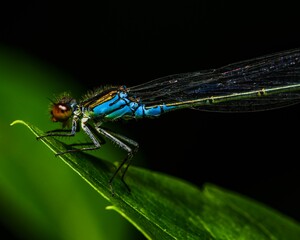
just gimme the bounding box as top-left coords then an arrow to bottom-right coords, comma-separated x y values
0,1 -> 300,234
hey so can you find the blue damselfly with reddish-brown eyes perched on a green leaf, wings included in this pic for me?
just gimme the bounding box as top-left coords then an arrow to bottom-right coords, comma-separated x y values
39,49 -> 300,191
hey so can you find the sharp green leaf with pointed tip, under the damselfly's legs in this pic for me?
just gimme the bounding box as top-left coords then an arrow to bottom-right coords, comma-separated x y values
12,120 -> 300,240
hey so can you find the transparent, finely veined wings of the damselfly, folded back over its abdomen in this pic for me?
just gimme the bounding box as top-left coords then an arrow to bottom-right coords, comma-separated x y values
129,49 -> 300,111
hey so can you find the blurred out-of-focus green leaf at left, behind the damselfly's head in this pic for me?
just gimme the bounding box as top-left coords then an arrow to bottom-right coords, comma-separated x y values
0,45 -> 134,240
